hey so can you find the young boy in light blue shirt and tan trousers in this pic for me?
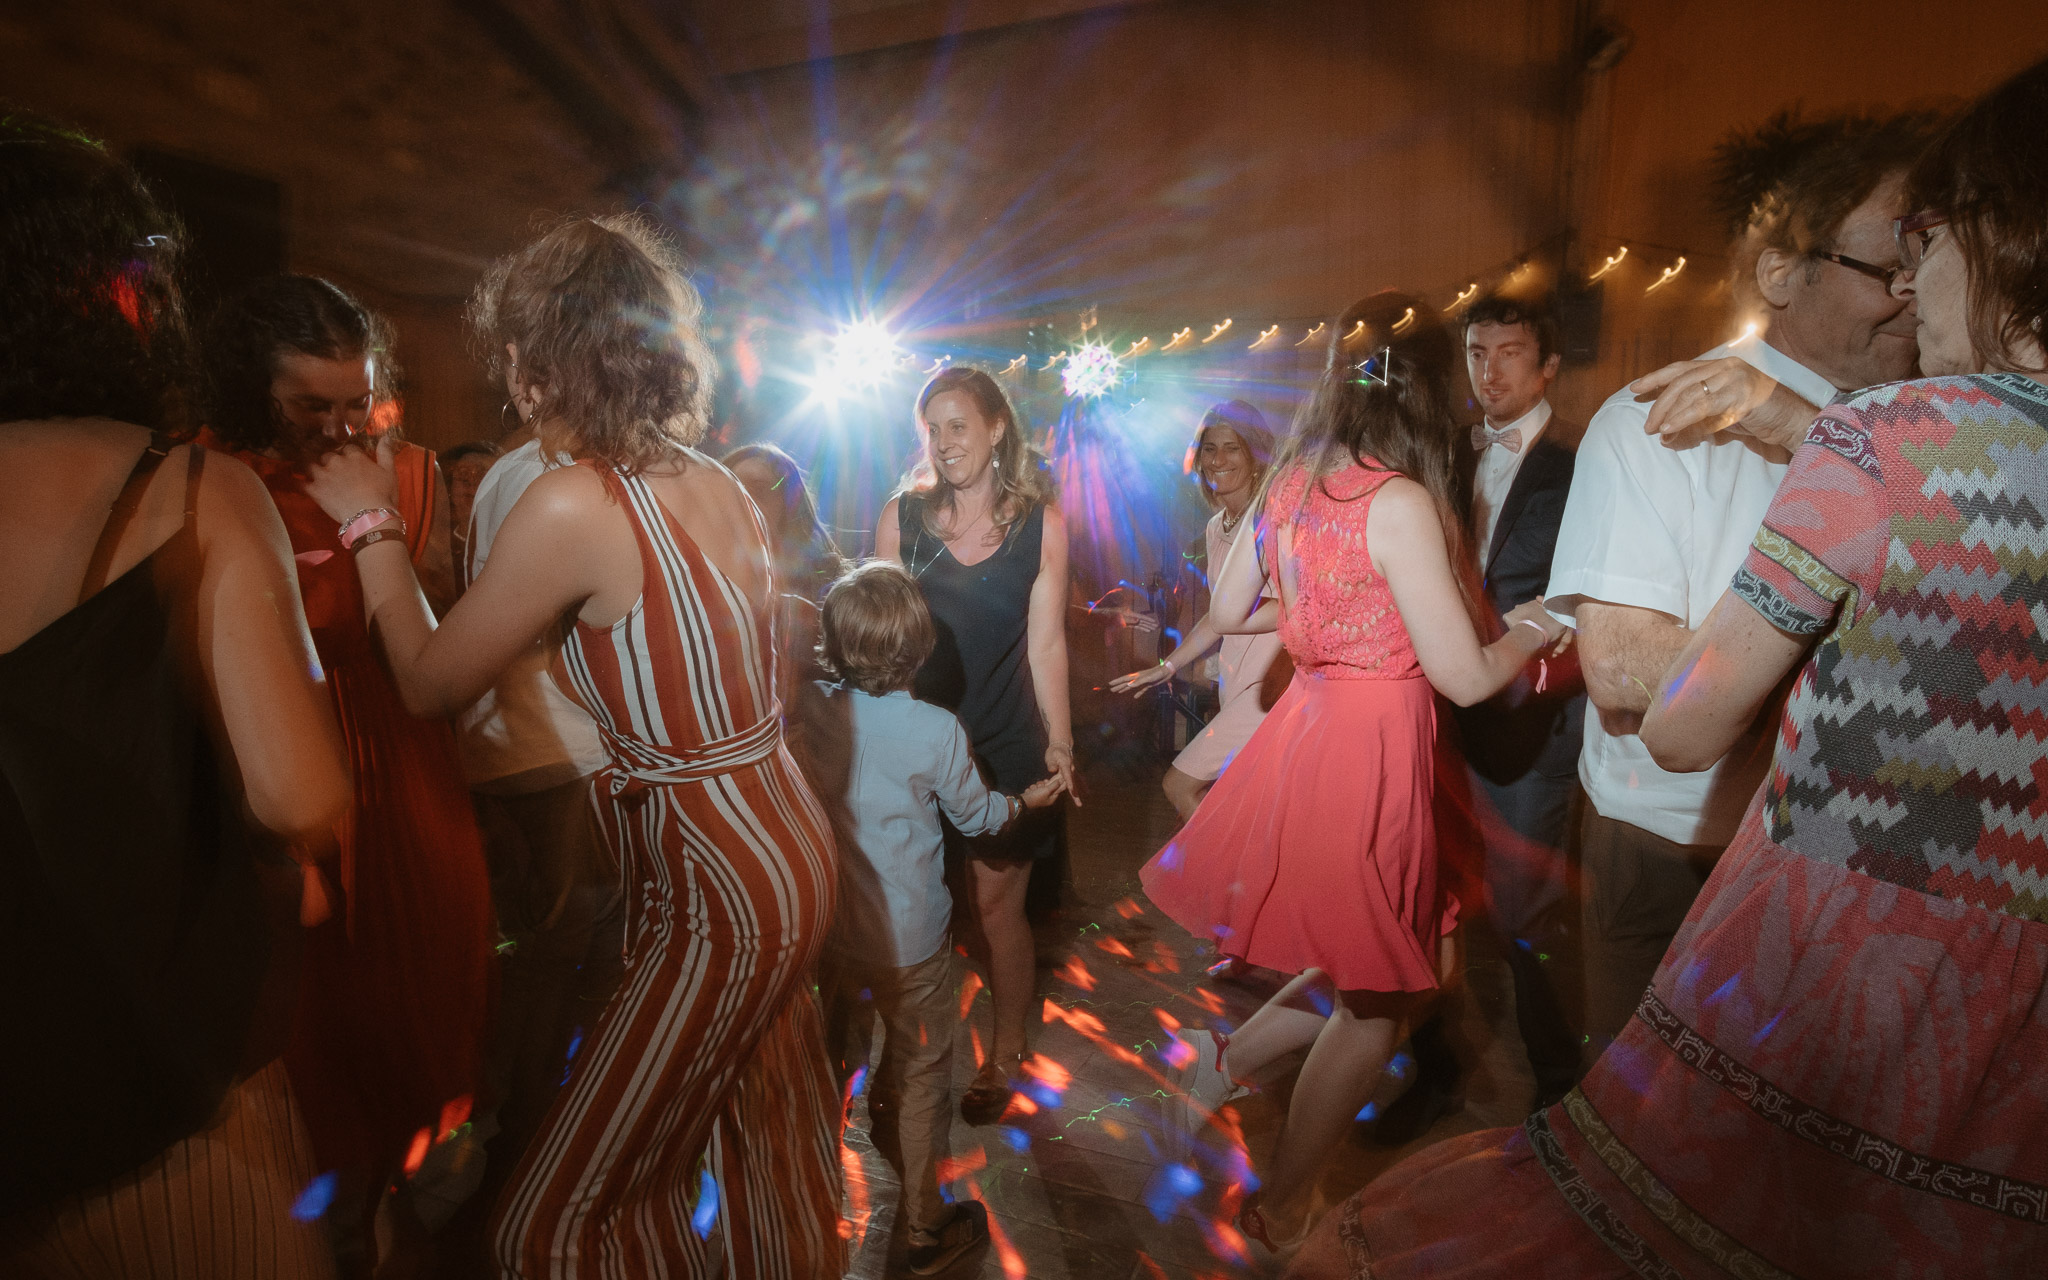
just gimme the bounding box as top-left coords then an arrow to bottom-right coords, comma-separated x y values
803,561 -> 1061,1276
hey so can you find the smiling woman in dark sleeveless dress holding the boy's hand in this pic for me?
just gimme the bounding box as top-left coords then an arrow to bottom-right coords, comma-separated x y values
874,367 -> 1079,1124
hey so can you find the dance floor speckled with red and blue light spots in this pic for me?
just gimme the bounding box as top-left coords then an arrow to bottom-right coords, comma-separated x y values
844,753 -> 1534,1280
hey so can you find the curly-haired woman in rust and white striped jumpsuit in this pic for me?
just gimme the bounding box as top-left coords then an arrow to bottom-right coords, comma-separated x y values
309,217 -> 844,1280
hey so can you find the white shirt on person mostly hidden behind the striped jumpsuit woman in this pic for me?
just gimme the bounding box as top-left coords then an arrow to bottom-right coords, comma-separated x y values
457,440 -> 604,795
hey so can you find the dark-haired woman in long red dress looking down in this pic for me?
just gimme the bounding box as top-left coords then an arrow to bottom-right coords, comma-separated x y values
207,276 -> 492,1257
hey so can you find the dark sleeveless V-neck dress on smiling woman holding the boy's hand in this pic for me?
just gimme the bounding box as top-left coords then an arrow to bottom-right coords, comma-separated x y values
897,494 -> 1044,793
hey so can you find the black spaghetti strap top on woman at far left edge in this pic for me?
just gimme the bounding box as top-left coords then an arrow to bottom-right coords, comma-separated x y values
0,436 -> 293,1217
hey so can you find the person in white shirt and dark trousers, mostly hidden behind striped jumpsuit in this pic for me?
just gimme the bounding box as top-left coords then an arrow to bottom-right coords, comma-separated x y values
457,430 -> 625,1210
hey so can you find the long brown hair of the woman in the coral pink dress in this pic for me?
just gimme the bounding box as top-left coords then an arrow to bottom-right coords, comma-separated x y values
1257,289 -> 1477,616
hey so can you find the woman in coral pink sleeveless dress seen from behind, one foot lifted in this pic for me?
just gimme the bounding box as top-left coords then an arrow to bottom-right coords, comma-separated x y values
1141,293 -> 1565,1253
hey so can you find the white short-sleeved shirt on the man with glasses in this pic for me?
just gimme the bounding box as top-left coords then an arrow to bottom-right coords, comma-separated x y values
1544,338 -> 1835,844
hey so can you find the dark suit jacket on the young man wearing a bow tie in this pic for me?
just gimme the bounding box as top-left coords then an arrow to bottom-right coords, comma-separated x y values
1458,416 -> 1585,784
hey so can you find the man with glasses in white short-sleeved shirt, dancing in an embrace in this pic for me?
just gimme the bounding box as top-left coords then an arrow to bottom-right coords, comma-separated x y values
1544,117 -> 1925,1051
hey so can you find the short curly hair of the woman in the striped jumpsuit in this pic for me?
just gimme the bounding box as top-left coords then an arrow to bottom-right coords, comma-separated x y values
469,213 -> 715,475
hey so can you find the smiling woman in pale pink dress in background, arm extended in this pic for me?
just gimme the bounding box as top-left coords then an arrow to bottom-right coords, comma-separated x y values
1110,399 -> 1284,819
